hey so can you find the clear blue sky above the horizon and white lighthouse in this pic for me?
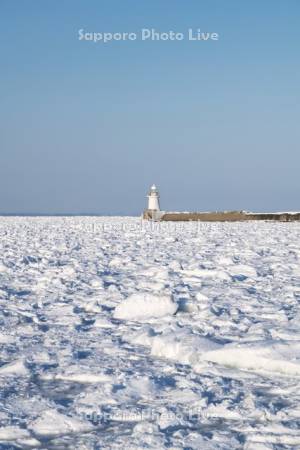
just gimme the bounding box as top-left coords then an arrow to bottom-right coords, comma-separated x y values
0,0 -> 300,215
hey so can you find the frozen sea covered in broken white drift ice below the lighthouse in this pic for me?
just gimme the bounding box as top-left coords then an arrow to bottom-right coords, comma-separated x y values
0,217 -> 300,450
